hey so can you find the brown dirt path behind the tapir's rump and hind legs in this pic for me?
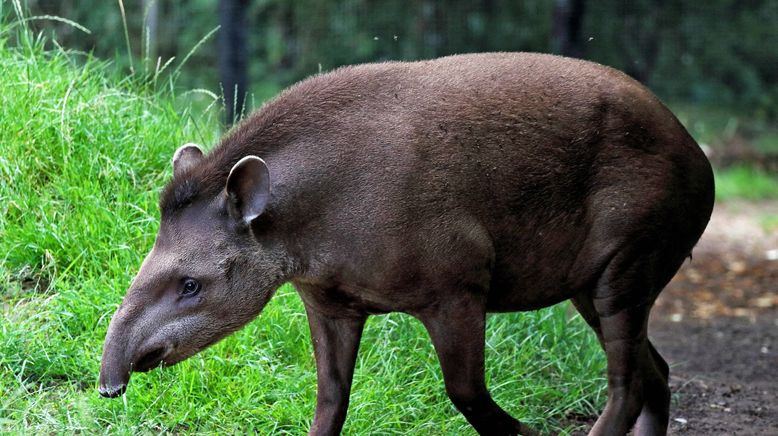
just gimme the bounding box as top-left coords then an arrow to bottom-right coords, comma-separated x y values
649,202 -> 778,435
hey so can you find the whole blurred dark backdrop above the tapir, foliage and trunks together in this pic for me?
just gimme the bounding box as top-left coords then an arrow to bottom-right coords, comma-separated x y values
18,0 -> 778,173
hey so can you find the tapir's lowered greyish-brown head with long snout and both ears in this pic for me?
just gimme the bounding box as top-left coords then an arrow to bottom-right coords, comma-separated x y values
99,144 -> 283,397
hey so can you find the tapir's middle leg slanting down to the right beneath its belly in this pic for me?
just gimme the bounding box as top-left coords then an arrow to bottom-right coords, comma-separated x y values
415,292 -> 536,435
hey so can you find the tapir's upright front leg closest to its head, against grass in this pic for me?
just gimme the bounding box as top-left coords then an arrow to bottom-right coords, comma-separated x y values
305,304 -> 366,435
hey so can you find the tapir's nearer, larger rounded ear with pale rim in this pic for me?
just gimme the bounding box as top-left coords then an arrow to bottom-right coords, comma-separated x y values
227,156 -> 270,224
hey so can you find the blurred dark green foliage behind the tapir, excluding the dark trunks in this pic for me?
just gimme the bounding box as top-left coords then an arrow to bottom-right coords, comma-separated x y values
15,0 -> 778,120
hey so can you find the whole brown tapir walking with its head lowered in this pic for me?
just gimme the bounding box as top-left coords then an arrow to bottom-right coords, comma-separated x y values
100,53 -> 714,435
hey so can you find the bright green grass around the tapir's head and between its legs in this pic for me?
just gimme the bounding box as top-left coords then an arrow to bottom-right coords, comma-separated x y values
0,6 -> 605,434
